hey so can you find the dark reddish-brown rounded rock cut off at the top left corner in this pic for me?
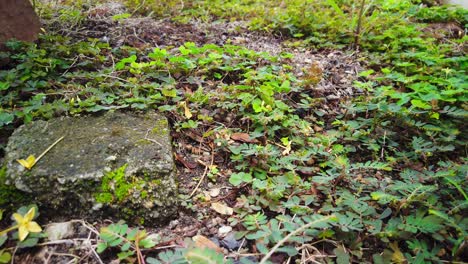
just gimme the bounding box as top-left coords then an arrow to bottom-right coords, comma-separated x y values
0,0 -> 40,50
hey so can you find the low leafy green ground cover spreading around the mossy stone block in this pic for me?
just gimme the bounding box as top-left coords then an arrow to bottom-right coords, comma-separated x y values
0,0 -> 468,263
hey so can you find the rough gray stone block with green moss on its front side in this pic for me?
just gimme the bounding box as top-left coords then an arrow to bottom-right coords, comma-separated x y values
6,112 -> 177,223
